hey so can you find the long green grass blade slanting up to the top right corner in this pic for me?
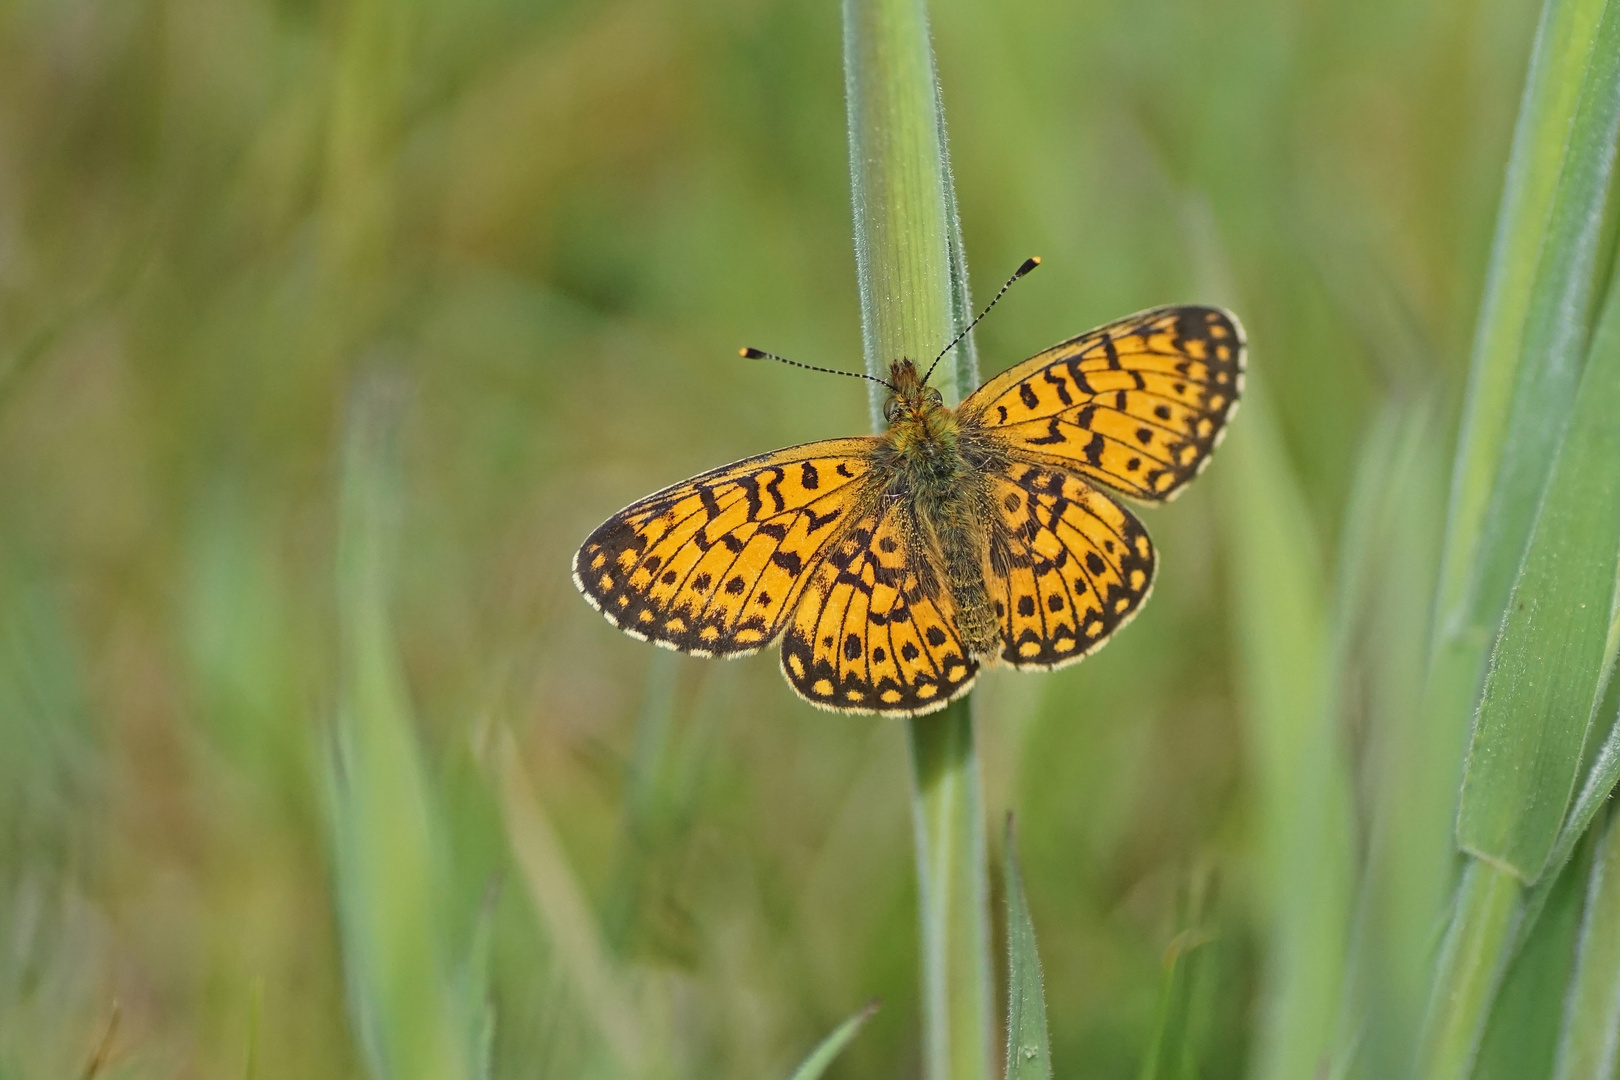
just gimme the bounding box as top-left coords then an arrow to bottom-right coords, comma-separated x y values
1424,0 -> 1614,906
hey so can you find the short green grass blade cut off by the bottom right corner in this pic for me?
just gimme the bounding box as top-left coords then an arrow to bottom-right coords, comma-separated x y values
1552,814 -> 1620,1080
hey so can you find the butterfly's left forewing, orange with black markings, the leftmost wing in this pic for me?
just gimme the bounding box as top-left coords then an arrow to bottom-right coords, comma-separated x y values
573,437 -> 876,656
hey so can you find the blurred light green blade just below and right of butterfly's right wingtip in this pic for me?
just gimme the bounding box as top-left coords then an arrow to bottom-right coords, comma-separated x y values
1220,369 -> 1351,1080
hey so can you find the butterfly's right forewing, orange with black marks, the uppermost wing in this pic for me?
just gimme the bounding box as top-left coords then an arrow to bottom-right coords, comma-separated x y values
959,306 -> 1244,502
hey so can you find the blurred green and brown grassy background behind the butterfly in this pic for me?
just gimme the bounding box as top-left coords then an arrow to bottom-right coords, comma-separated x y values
0,0 -> 1536,1080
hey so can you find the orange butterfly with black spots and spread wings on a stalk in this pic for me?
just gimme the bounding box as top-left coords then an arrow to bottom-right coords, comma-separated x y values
573,259 -> 1244,716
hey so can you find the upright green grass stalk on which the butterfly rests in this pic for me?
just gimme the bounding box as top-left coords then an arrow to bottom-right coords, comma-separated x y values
844,0 -> 993,1080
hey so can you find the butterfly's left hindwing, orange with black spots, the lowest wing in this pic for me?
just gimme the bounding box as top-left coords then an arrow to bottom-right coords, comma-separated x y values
782,495 -> 978,716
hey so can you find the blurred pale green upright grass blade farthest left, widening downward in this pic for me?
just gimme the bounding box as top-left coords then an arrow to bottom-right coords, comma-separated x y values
330,379 -> 481,1080
